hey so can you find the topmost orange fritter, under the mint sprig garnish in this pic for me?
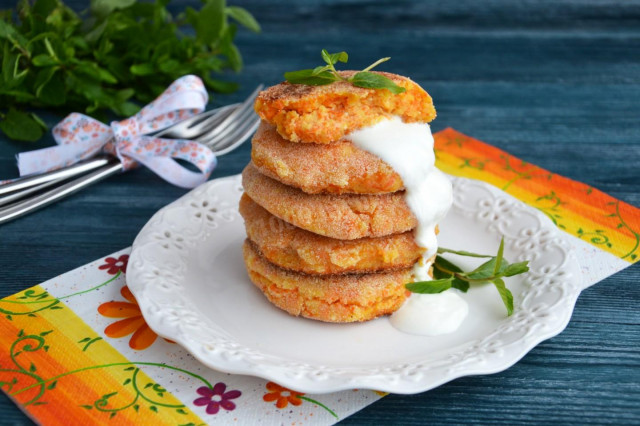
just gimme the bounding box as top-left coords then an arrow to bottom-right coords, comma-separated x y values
255,71 -> 436,143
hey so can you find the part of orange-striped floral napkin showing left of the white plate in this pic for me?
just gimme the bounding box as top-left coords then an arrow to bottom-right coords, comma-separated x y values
0,249 -> 381,425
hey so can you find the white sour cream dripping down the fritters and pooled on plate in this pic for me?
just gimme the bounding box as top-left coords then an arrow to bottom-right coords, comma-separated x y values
348,117 -> 468,336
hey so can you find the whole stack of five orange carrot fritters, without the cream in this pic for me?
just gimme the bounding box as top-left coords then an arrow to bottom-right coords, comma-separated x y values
240,71 -> 435,322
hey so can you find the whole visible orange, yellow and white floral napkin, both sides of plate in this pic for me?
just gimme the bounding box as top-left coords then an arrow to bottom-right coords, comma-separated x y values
0,129 -> 640,425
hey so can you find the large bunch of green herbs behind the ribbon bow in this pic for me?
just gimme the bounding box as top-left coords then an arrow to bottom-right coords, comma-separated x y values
0,0 -> 260,141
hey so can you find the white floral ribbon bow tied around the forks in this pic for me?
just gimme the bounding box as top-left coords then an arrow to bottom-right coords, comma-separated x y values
18,75 -> 217,188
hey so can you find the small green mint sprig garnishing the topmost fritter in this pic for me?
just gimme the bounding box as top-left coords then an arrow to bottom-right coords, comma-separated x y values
284,49 -> 406,94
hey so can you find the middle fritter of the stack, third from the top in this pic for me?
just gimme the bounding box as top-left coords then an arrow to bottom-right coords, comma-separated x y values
242,163 -> 418,240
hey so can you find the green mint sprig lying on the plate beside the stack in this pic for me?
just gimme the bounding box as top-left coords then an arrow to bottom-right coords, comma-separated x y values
406,237 -> 529,315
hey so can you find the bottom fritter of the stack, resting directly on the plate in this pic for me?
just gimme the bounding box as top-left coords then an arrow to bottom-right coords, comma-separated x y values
243,240 -> 411,322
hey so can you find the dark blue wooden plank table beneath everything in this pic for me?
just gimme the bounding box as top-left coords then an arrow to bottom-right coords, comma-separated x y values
0,0 -> 640,425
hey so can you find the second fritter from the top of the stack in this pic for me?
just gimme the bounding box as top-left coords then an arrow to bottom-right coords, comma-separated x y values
251,121 -> 403,194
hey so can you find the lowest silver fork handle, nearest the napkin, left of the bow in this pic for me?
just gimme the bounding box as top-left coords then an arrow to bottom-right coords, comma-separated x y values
0,158 -> 122,224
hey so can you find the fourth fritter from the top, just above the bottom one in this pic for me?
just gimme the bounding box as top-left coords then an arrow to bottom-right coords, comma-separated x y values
240,194 -> 424,274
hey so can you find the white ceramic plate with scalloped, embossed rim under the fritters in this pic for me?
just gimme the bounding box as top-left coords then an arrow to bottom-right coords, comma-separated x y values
127,176 -> 581,393
